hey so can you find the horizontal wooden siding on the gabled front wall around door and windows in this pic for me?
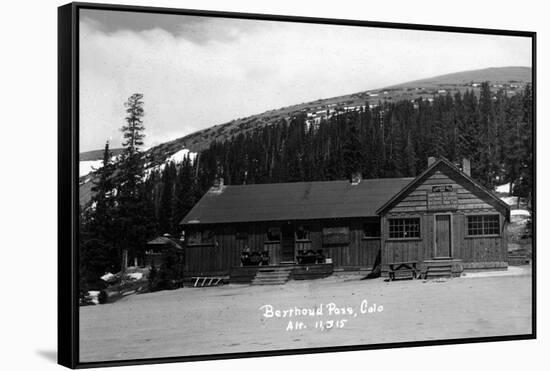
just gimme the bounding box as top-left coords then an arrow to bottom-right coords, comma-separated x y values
381,171 -> 507,265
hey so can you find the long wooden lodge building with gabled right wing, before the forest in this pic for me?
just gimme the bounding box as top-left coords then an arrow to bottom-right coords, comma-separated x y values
181,158 -> 510,278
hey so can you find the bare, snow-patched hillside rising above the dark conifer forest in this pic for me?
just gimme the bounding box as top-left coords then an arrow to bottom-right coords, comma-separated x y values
80,67 -> 531,203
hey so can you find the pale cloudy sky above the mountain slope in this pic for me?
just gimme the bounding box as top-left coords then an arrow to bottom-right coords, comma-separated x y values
79,10 -> 531,152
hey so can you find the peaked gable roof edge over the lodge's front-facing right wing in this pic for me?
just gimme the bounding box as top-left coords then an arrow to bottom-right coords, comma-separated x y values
376,157 -> 510,219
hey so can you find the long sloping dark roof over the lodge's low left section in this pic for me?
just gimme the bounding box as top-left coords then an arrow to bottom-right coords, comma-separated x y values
180,178 -> 414,225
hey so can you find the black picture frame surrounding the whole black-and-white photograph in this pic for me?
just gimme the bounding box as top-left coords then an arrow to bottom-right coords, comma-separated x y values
58,2 -> 537,368
